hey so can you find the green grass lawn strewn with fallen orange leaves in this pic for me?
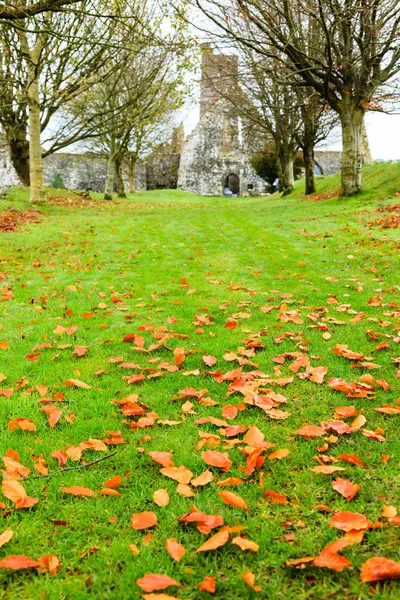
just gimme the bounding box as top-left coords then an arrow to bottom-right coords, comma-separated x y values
0,164 -> 400,600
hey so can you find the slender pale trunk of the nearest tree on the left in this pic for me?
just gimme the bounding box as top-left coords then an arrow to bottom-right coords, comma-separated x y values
28,71 -> 47,204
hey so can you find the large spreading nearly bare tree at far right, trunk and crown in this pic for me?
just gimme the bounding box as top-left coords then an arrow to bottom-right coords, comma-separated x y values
194,0 -> 400,196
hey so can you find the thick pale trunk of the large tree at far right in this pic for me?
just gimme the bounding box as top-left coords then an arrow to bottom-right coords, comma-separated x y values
340,100 -> 364,198
